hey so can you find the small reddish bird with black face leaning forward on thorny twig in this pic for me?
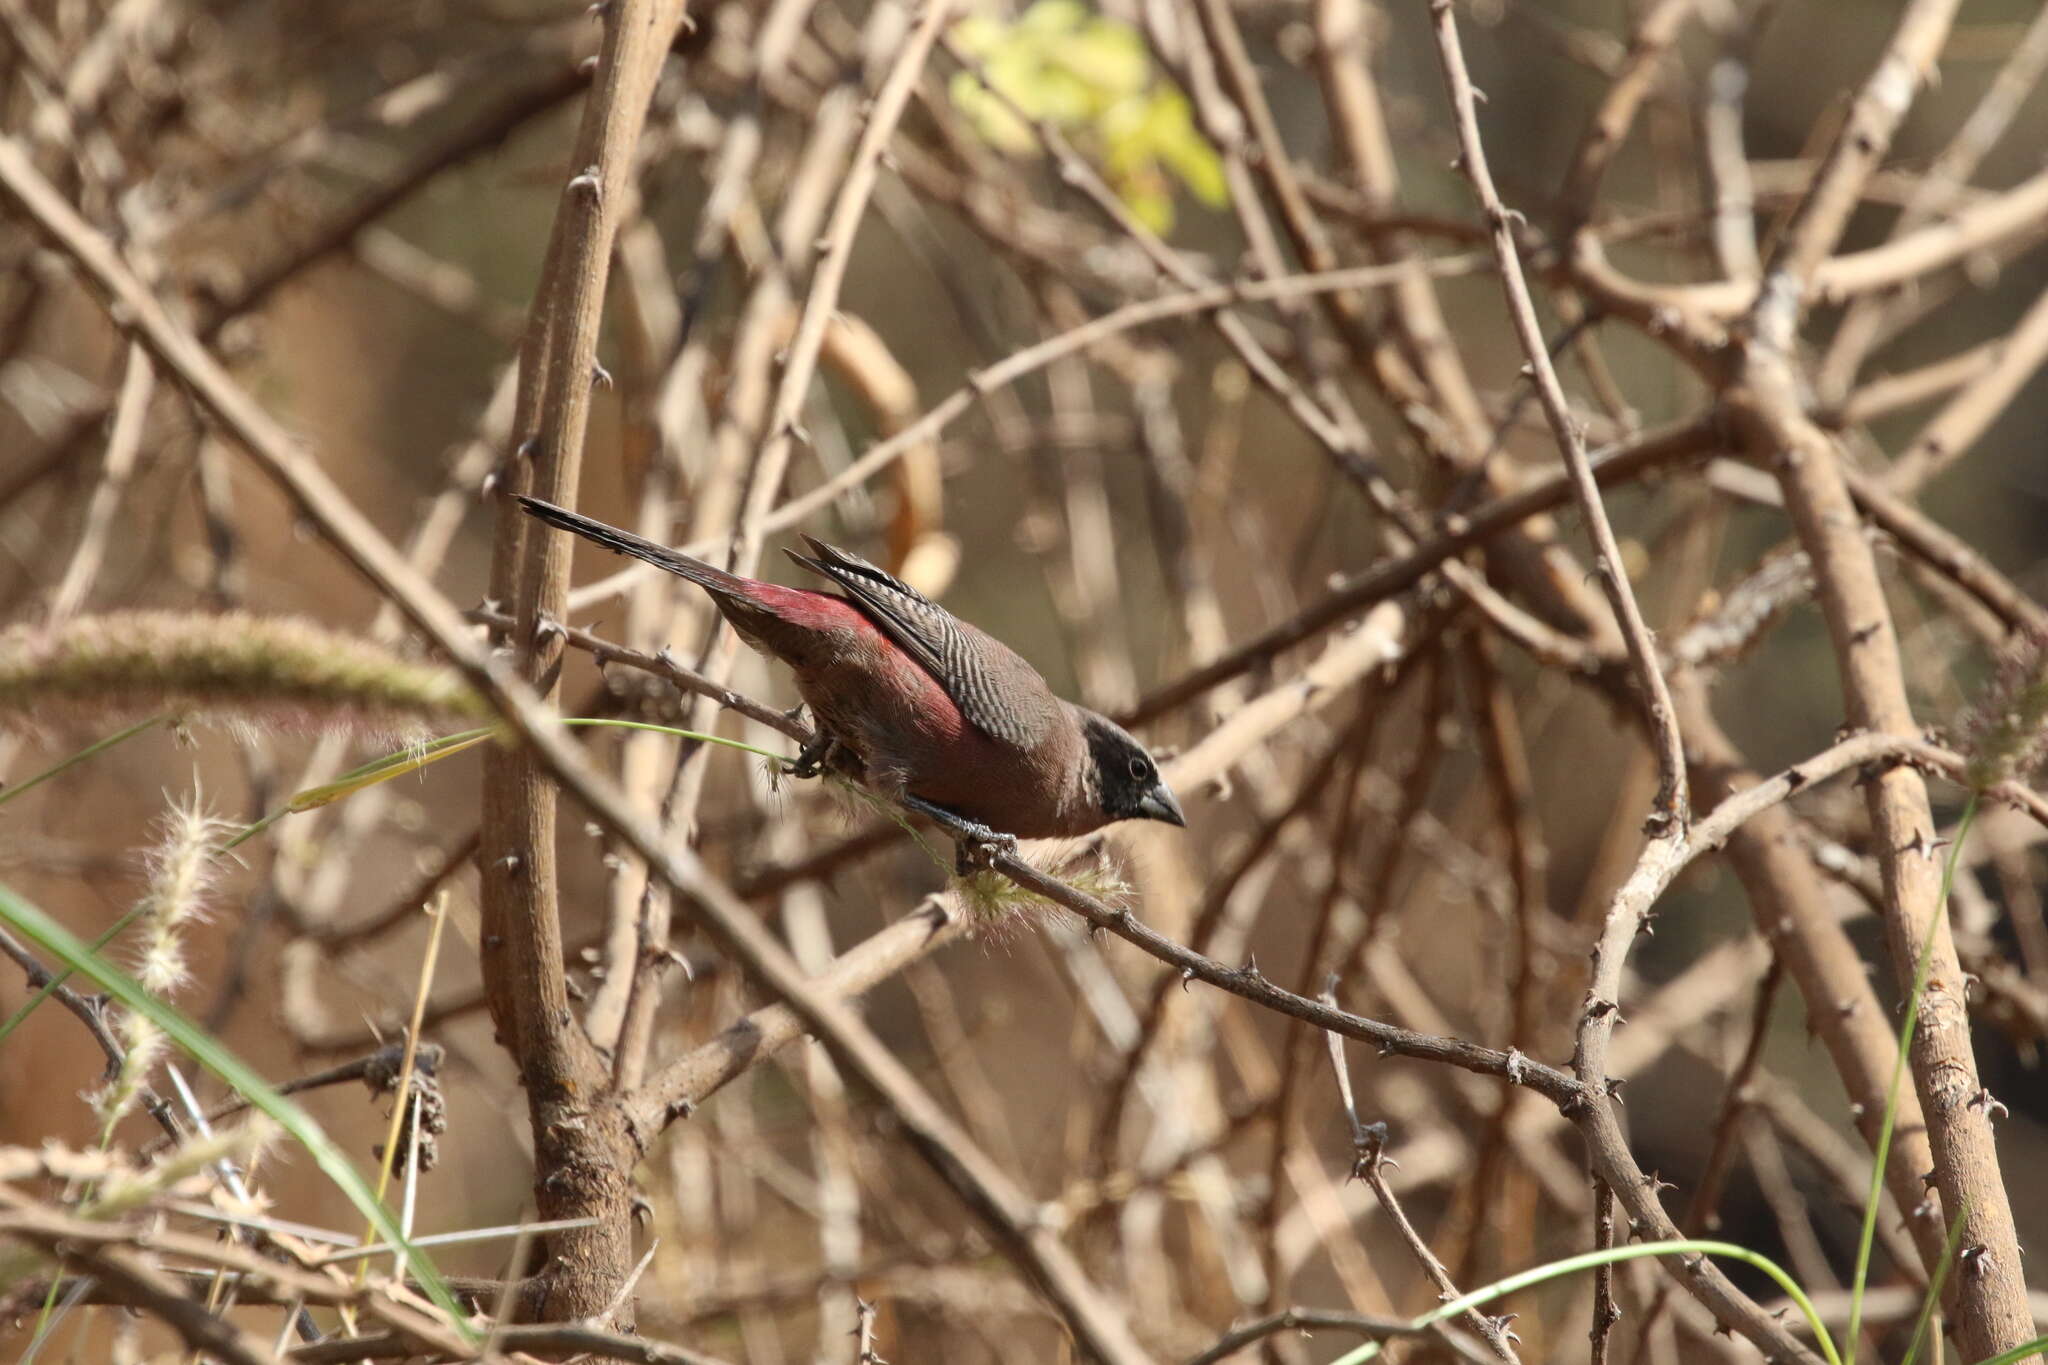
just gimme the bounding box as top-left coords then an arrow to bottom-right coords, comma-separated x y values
518,495 -> 1188,870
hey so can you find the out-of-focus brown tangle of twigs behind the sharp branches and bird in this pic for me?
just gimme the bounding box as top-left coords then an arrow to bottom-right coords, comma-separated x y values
0,0 -> 2048,1361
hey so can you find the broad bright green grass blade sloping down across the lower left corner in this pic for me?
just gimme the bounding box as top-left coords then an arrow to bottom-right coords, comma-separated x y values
0,884 -> 481,1340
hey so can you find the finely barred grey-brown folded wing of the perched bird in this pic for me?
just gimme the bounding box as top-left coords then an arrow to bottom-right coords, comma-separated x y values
788,536 -> 1051,745
